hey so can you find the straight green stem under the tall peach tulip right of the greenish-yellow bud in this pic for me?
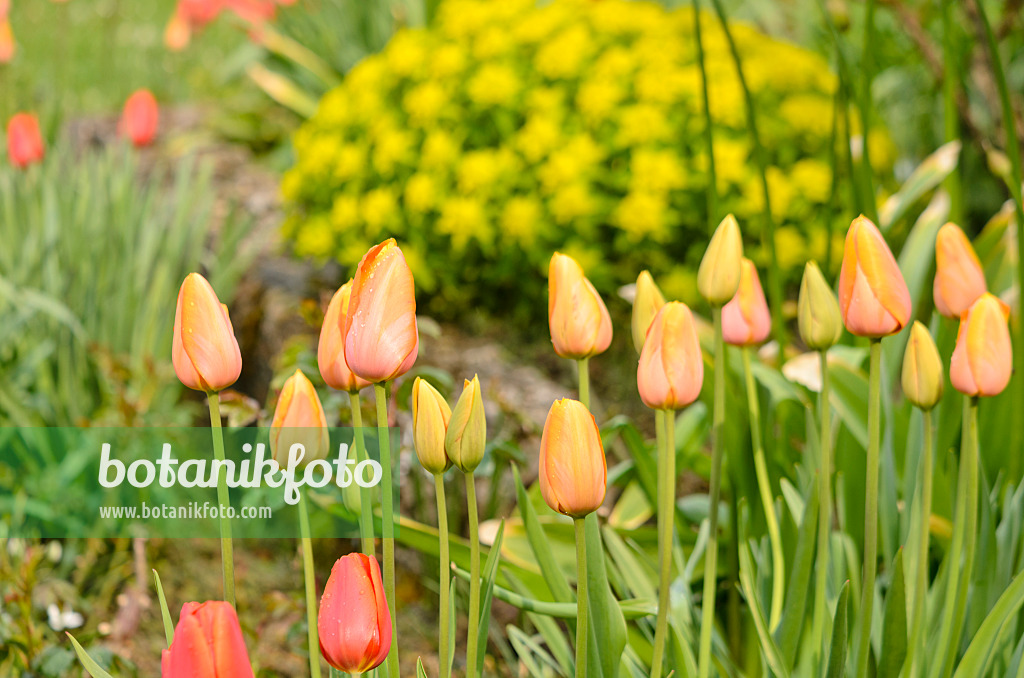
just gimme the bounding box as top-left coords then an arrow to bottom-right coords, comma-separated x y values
854,339 -> 882,678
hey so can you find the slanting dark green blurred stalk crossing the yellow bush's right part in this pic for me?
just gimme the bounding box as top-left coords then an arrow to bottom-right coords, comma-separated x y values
712,0 -> 786,346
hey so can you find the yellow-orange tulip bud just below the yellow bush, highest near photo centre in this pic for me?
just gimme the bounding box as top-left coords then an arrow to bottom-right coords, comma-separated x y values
548,252 -> 611,359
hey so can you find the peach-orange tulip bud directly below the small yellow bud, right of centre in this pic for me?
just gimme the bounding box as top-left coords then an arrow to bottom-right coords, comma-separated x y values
637,301 -> 703,410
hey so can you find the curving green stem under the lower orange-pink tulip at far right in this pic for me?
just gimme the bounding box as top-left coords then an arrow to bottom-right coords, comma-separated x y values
932,395 -> 978,677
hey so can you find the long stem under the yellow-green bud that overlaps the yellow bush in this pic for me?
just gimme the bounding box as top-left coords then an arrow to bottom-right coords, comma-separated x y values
697,306 -> 726,678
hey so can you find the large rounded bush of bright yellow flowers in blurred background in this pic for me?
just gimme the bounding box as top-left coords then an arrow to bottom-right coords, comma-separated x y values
283,0 -> 892,312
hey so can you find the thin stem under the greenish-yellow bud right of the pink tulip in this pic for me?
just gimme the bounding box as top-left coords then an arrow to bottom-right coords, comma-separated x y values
811,350 -> 831,666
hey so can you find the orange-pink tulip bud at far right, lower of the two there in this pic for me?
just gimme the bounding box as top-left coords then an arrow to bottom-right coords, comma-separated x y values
949,292 -> 1014,396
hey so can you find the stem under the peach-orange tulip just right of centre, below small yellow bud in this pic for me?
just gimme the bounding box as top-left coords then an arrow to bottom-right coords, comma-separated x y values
650,410 -> 676,678
